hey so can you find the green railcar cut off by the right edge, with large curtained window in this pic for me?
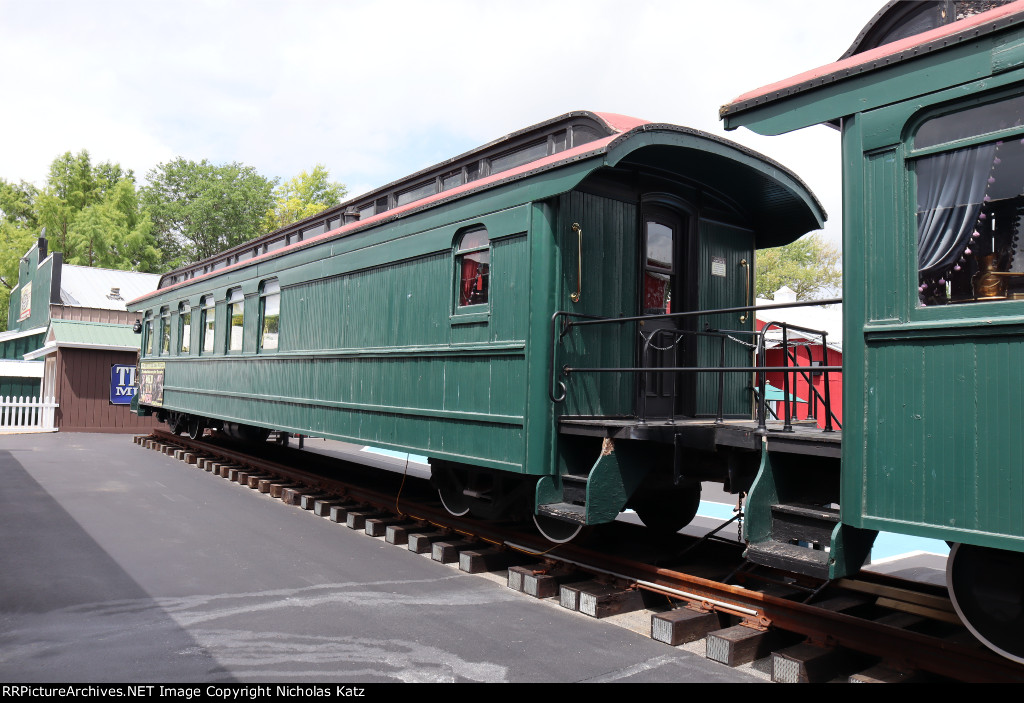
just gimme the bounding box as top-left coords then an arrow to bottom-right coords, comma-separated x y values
722,2 -> 1024,662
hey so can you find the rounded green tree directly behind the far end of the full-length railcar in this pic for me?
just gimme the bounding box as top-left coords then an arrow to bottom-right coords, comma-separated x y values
141,157 -> 276,267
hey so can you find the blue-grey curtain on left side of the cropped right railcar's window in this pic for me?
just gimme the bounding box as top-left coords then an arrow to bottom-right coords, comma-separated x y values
915,143 -> 995,284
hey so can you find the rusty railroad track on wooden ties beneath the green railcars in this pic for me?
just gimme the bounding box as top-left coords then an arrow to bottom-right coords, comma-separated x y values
135,431 -> 1024,683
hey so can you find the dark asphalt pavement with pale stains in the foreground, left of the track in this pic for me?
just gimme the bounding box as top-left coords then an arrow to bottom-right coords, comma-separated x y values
0,433 -> 763,684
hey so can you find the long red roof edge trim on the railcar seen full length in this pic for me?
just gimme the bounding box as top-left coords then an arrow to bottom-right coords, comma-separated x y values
127,112 -> 647,307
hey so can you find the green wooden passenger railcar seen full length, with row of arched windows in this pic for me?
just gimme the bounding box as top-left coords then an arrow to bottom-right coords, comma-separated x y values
132,113 -> 824,537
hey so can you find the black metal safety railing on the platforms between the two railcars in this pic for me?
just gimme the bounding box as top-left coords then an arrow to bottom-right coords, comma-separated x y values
549,298 -> 843,432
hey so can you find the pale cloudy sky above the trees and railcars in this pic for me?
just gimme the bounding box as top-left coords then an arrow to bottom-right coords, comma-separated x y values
0,0 -> 883,247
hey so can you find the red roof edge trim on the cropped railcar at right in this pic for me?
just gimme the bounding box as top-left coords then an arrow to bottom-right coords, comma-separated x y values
722,0 -> 1024,110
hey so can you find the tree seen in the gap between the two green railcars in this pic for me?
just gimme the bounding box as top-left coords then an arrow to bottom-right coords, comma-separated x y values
755,233 -> 843,300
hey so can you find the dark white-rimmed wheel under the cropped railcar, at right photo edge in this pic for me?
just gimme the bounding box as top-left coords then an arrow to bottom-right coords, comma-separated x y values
946,544 -> 1024,664
